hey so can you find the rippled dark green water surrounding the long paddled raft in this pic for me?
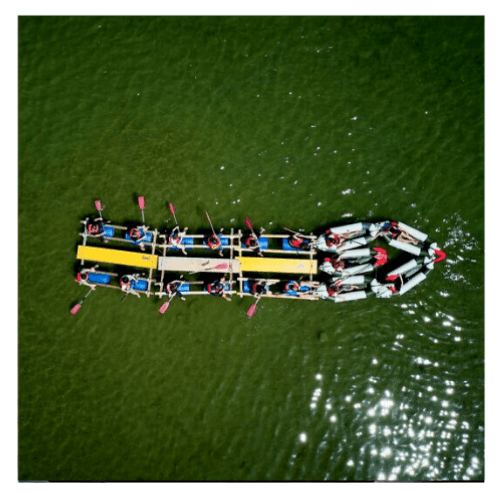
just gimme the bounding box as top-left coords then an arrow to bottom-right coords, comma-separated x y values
18,17 -> 484,481
